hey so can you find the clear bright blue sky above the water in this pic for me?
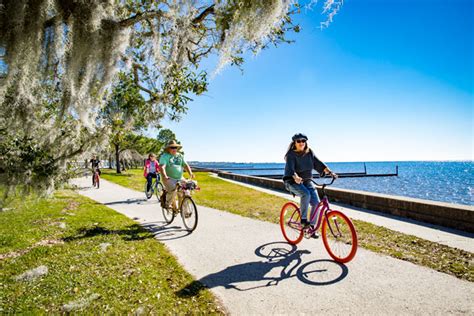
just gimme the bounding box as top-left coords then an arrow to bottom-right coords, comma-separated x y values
157,0 -> 474,162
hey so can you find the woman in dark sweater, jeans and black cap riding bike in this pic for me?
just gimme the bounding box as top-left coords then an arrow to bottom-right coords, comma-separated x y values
283,133 -> 337,237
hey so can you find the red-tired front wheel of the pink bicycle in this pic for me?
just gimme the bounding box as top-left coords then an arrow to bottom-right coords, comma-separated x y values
321,210 -> 357,263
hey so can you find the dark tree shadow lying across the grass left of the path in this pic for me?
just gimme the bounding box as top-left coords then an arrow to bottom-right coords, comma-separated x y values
63,224 -> 154,242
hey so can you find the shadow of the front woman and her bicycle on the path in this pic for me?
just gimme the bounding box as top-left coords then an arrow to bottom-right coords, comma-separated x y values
177,242 -> 348,297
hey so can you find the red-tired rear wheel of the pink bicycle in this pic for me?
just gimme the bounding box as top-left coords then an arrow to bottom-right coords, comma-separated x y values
280,202 -> 303,245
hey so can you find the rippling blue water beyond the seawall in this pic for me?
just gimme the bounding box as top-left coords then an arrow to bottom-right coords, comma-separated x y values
192,161 -> 474,205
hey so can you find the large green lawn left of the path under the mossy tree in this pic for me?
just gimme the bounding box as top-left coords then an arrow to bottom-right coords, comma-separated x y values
0,190 -> 223,315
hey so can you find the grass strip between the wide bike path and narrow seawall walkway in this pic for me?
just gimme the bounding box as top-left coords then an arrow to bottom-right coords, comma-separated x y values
104,170 -> 474,282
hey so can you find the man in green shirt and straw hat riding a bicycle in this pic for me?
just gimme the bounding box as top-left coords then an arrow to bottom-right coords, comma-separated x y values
160,140 -> 194,207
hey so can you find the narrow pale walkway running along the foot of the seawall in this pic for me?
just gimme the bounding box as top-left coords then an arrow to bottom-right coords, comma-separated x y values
216,176 -> 474,253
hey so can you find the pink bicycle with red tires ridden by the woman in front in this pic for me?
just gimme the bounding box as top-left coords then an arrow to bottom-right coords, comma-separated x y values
280,177 -> 357,263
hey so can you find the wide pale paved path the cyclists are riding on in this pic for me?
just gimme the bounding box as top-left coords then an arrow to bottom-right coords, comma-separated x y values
71,178 -> 474,315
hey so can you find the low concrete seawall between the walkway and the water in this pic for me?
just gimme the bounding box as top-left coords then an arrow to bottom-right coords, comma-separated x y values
218,172 -> 474,233
